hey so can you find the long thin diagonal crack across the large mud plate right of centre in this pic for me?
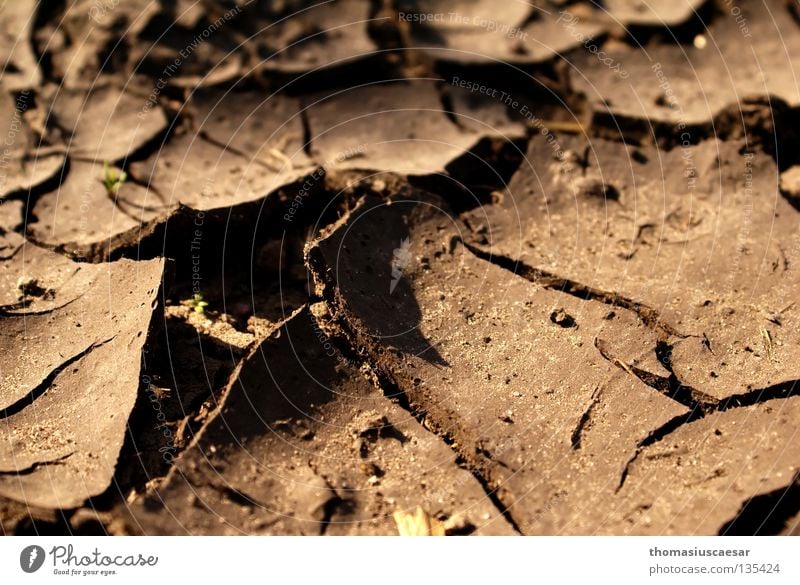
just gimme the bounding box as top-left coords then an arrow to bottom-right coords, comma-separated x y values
463,242 -> 689,341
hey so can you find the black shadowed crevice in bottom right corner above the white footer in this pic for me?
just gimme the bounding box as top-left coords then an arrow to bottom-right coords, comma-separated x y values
719,473 -> 800,536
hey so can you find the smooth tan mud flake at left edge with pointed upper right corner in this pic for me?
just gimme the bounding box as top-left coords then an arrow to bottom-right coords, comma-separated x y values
0,244 -> 163,508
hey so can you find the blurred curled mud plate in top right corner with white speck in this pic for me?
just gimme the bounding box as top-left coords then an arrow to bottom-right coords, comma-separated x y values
572,0 -> 800,136
